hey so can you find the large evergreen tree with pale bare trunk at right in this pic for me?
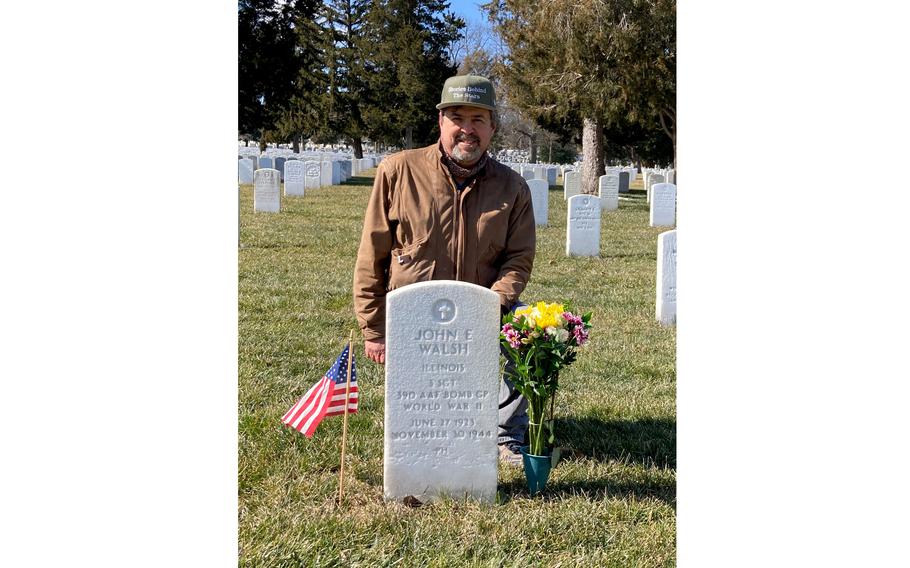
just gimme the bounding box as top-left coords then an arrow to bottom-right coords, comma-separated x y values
484,0 -> 675,193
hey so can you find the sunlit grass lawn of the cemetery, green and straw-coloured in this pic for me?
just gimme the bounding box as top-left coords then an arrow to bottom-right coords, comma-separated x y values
238,170 -> 676,567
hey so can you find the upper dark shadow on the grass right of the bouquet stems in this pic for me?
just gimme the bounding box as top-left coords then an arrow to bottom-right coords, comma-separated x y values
556,418 -> 676,469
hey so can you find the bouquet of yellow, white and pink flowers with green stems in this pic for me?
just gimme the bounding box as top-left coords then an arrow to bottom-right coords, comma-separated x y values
499,302 -> 591,494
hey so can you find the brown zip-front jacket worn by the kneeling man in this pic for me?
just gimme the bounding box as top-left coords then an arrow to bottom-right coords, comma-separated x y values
354,144 -> 535,340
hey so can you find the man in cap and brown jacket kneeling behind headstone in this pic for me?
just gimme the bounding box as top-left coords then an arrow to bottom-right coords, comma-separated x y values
354,75 -> 536,465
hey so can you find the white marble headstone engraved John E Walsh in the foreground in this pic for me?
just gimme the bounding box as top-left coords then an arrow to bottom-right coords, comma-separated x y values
383,281 -> 500,503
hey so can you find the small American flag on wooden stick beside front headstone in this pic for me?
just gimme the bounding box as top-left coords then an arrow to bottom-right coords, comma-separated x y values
281,345 -> 358,438
